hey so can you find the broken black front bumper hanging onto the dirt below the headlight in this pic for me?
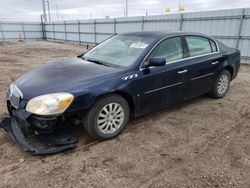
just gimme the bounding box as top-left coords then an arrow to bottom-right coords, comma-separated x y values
0,110 -> 77,155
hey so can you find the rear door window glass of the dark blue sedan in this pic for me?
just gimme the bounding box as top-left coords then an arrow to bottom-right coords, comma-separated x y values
185,36 -> 212,56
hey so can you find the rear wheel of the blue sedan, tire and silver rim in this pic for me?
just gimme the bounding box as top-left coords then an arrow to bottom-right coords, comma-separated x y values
210,70 -> 231,99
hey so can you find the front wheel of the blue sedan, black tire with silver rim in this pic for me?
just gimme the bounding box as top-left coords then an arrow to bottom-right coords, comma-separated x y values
84,94 -> 130,140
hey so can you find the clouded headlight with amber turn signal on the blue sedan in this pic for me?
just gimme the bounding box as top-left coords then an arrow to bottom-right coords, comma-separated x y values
26,93 -> 74,115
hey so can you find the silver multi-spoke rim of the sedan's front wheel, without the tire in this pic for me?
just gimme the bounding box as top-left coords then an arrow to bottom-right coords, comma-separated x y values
97,103 -> 124,134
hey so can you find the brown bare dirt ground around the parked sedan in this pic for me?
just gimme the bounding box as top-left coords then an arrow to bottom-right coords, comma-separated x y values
0,42 -> 250,188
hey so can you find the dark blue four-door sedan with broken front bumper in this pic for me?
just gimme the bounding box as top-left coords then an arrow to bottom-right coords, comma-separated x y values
1,32 -> 240,154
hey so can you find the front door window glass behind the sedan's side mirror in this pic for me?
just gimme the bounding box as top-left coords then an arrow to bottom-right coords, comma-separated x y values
151,37 -> 183,63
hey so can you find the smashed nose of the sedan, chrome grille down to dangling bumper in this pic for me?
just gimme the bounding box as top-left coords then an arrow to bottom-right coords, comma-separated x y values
0,84 -> 77,155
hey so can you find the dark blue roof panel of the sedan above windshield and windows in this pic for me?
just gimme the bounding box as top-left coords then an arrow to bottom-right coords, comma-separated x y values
120,31 -> 214,40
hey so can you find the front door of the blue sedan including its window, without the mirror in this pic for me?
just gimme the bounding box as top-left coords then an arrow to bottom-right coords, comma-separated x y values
140,37 -> 188,113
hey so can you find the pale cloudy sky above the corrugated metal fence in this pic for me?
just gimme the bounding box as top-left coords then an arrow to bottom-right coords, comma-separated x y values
0,0 -> 250,21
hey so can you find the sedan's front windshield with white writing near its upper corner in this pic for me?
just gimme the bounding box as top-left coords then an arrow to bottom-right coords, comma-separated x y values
83,36 -> 153,68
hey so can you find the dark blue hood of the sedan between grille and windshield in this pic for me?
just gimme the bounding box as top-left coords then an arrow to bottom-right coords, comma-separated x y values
14,57 -> 122,100
